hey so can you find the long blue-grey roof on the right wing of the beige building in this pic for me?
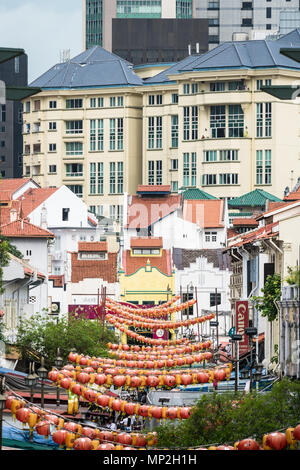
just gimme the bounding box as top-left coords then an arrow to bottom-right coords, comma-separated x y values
144,29 -> 300,85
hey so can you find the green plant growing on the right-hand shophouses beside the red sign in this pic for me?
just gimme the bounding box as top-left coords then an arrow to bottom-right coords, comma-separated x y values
252,274 -> 281,321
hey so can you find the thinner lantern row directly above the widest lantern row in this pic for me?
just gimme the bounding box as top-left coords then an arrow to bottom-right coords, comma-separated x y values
69,351 -> 213,371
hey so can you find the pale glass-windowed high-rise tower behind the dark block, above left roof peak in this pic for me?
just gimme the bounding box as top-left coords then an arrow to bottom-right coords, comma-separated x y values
83,0 -> 195,51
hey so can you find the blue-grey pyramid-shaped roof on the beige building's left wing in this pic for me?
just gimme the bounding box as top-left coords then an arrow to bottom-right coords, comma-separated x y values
31,46 -> 143,88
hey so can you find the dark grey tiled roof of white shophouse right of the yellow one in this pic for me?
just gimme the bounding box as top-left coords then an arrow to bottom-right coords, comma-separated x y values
173,248 -> 230,270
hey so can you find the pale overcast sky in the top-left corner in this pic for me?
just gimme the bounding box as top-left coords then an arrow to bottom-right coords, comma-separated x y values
0,0 -> 83,83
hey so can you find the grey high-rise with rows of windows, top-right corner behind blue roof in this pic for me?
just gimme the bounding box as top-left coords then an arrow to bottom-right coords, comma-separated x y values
194,0 -> 299,48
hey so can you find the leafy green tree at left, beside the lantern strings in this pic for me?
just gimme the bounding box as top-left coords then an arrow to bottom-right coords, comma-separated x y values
15,314 -> 117,367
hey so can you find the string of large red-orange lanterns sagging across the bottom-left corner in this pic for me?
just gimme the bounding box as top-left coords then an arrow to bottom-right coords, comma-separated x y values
6,395 -> 157,450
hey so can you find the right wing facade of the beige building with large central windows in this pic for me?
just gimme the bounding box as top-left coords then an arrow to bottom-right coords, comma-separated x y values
143,69 -> 300,198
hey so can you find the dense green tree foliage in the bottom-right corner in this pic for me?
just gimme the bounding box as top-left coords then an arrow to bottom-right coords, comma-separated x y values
155,379 -> 300,448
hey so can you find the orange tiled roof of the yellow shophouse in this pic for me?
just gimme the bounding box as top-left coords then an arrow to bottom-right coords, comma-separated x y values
122,250 -> 172,276
